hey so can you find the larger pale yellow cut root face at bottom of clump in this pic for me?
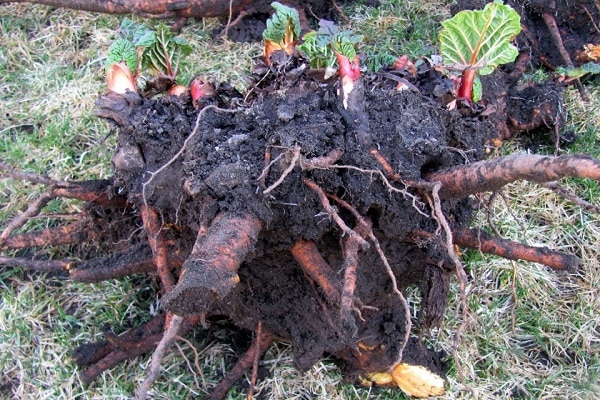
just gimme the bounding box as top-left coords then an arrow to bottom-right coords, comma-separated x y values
391,363 -> 445,397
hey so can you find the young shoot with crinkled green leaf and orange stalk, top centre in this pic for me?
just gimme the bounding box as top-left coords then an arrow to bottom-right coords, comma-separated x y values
263,1 -> 301,63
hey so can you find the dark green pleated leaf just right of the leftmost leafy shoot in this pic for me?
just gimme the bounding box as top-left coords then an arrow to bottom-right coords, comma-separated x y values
142,24 -> 192,78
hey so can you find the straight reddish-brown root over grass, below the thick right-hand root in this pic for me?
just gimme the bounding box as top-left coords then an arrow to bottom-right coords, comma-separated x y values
453,228 -> 579,271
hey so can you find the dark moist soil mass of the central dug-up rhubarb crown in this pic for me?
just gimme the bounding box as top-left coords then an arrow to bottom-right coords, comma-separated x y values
99,55 -> 497,382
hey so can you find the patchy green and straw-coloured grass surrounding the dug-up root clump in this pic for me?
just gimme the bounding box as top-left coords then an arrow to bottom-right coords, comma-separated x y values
0,0 -> 600,400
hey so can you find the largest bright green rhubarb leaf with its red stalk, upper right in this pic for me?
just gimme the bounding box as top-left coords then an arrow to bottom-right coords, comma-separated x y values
439,0 -> 521,102
